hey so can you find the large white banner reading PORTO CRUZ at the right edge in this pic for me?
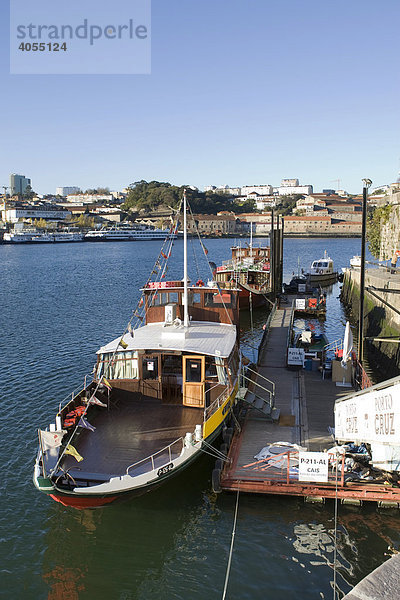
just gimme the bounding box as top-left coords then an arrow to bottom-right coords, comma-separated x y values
335,383 -> 400,443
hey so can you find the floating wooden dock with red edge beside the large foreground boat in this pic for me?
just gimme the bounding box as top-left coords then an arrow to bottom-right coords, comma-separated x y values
220,300 -> 400,508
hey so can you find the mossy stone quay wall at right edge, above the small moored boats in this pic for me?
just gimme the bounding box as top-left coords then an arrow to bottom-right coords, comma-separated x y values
341,269 -> 400,380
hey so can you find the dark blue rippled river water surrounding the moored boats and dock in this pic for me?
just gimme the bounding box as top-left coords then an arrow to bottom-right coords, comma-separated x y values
0,239 -> 400,600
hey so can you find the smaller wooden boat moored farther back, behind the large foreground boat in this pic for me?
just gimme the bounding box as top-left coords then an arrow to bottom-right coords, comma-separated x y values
214,244 -> 271,309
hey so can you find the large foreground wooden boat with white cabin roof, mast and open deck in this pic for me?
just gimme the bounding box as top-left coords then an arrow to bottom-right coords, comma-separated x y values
33,195 -> 241,508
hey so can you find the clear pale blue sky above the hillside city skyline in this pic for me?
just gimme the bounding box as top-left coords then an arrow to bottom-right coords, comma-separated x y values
0,0 -> 400,193
